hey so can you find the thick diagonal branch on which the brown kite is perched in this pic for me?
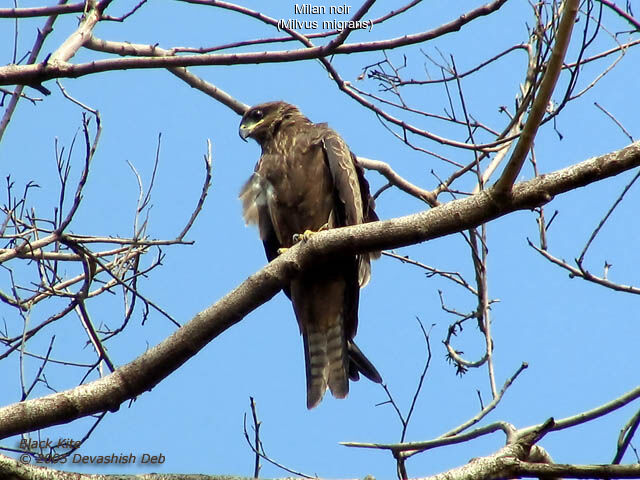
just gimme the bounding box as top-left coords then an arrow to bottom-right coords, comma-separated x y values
0,142 -> 640,438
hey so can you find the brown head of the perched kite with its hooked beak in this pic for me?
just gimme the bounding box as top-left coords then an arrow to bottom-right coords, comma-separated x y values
239,102 -> 304,145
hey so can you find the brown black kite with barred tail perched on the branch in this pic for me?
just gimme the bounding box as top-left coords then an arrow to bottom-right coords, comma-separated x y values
240,101 -> 382,409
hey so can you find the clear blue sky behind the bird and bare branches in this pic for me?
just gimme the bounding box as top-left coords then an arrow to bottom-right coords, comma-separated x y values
0,1 -> 640,478
